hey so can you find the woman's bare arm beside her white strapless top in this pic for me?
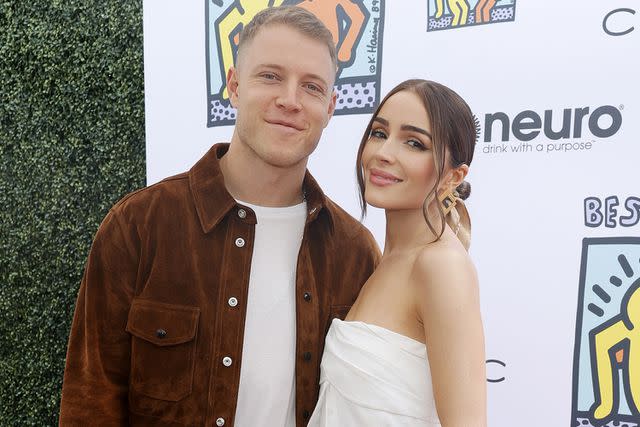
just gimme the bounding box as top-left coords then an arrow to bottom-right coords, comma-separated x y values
411,246 -> 487,427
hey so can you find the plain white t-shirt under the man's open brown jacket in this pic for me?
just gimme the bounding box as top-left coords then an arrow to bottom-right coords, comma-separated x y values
235,201 -> 307,427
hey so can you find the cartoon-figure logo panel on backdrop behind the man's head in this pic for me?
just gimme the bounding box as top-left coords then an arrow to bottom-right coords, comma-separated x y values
205,0 -> 386,127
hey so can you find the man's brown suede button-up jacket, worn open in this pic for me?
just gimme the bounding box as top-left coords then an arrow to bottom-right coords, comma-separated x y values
60,144 -> 380,427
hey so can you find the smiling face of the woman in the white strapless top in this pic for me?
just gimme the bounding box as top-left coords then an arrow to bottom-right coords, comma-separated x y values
362,90 -> 436,210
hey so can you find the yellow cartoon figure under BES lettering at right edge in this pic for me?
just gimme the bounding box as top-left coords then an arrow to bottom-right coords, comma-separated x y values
592,287 -> 640,420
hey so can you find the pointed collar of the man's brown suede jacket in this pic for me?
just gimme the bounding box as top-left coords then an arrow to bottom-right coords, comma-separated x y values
189,143 -> 333,233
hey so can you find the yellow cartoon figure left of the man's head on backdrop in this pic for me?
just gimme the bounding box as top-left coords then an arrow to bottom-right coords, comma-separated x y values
216,0 -> 284,99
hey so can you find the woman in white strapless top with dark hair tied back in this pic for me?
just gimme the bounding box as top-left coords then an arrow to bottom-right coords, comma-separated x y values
309,80 -> 486,427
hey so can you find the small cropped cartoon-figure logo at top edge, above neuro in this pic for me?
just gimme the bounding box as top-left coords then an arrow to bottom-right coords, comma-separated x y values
427,0 -> 516,31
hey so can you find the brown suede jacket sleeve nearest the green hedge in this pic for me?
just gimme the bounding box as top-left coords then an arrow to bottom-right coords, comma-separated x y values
60,210 -> 139,426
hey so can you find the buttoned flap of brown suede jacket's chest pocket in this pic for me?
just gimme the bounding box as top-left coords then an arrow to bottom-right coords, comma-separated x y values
126,299 -> 200,346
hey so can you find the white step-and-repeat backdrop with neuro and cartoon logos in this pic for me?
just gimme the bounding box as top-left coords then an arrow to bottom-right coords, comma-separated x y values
144,0 -> 640,427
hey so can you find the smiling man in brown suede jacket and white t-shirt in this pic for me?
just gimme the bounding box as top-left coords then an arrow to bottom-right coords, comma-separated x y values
60,7 -> 379,426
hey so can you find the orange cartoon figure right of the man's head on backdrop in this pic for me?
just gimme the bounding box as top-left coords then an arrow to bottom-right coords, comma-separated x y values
296,0 -> 366,62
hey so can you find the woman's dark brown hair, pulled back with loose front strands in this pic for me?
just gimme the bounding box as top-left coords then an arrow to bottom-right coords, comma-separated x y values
356,79 -> 479,240
